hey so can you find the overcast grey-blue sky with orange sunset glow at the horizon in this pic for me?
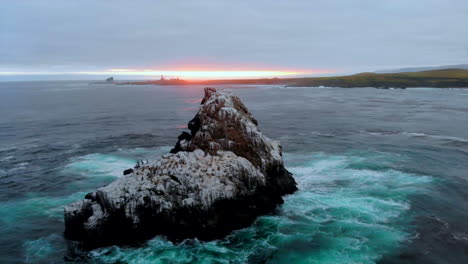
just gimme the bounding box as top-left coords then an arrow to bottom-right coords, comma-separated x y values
0,0 -> 468,79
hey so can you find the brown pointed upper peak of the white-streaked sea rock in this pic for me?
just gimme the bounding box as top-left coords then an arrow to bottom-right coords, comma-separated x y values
174,88 -> 283,169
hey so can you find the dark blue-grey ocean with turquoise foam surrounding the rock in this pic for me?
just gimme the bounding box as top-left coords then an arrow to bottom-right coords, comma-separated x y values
0,81 -> 468,264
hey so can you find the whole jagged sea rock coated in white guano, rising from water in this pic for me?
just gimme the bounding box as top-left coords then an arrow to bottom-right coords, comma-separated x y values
64,88 -> 297,247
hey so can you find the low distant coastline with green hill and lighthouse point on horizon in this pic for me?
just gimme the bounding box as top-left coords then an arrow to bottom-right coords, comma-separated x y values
116,69 -> 468,89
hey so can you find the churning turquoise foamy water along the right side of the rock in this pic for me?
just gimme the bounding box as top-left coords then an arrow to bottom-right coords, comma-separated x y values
85,153 -> 431,263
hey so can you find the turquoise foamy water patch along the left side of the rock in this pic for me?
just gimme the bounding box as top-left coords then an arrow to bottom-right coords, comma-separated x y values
0,147 -> 172,263
